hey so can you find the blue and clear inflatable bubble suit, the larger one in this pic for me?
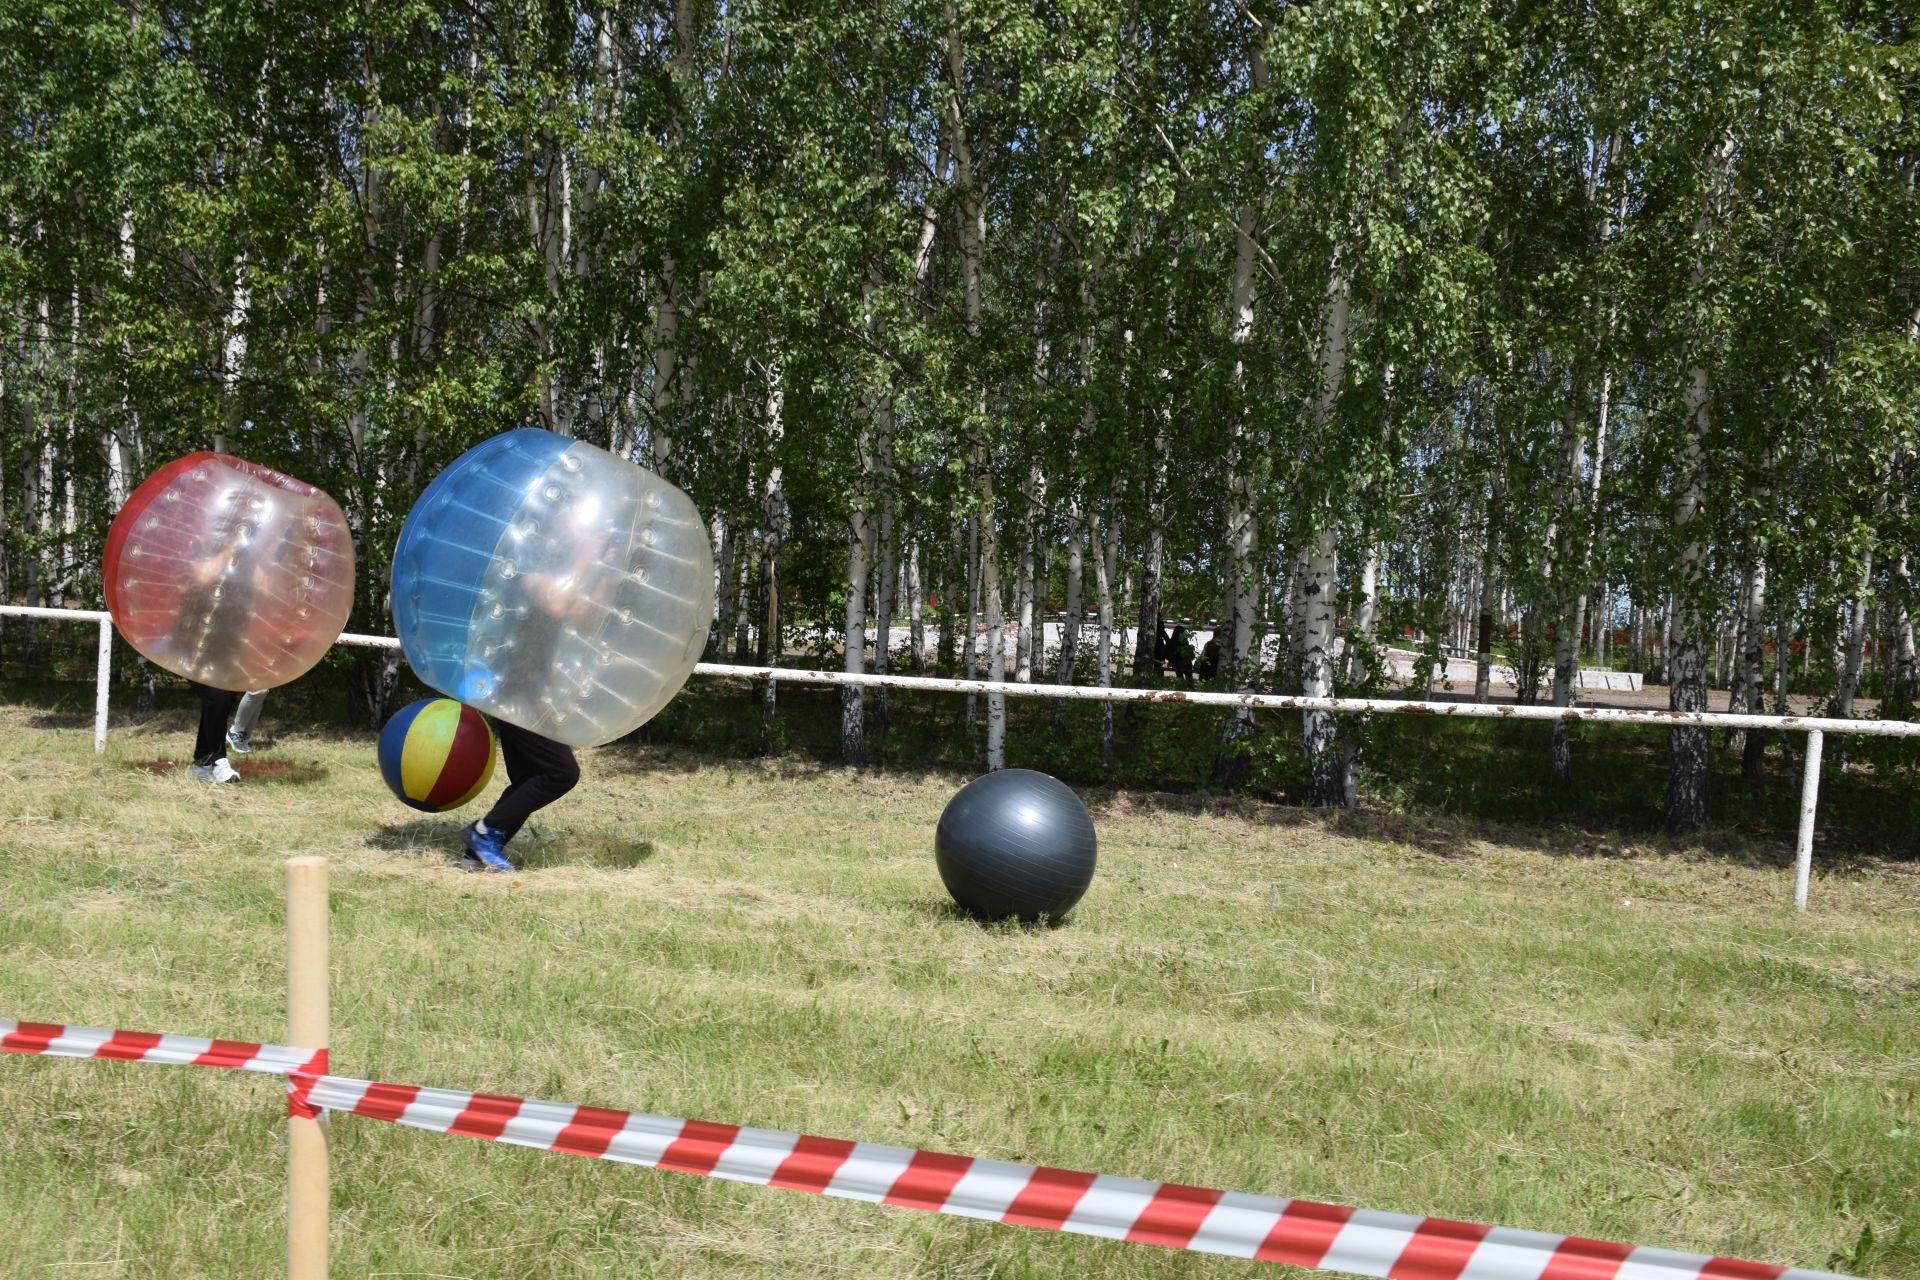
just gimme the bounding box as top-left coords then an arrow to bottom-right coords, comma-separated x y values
394,428 -> 714,747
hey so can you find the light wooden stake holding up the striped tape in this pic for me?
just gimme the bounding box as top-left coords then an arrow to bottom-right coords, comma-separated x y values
286,858 -> 330,1280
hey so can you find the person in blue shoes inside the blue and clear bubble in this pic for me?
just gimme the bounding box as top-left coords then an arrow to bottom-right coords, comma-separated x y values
459,510 -> 624,871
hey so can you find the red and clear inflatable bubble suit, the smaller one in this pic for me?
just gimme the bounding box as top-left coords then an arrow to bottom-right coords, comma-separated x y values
102,453 -> 353,689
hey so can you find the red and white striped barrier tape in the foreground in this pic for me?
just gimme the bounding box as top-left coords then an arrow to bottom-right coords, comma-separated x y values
0,1019 -> 1845,1280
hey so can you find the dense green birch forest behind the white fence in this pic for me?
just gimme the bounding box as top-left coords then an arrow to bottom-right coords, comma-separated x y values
0,0 -> 1920,833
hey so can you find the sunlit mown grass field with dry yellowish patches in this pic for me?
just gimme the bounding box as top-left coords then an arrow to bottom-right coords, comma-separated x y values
0,704 -> 1920,1278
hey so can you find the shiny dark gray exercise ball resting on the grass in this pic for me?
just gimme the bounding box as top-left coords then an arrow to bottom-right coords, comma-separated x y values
933,770 -> 1098,921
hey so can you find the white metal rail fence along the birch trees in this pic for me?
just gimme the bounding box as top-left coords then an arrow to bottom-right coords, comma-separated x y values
0,604 -> 1920,908
